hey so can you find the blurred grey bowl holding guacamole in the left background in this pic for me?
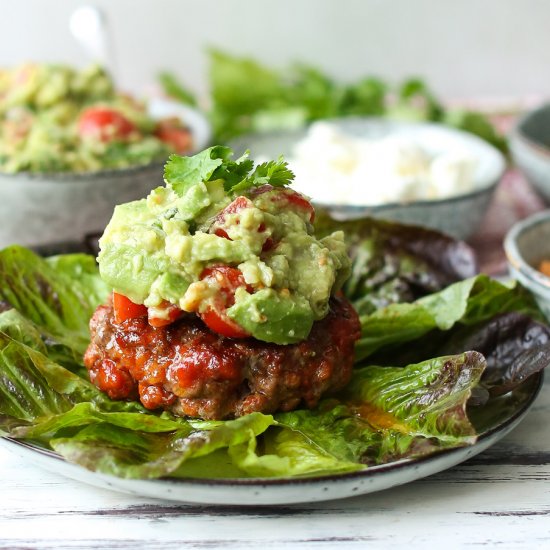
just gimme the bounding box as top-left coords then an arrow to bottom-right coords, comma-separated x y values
0,98 -> 211,247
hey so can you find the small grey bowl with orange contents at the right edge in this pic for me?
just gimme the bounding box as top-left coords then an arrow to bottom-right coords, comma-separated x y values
504,210 -> 550,320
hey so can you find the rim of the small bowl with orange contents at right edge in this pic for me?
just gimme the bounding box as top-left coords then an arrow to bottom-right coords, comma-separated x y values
503,209 -> 550,293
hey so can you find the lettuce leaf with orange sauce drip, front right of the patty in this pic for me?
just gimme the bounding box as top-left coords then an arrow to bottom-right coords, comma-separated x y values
268,352 -> 485,468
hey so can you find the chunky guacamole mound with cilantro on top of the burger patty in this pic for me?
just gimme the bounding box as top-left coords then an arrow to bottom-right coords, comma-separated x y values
98,146 -> 350,344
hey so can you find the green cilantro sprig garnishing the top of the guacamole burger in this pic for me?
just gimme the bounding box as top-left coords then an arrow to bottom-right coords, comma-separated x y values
164,145 -> 294,196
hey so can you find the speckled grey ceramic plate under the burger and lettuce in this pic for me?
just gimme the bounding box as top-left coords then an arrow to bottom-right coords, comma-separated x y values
0,373 -> 543,505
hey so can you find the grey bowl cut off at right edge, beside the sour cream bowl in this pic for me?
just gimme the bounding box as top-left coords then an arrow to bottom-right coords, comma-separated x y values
509,104 -> 550,203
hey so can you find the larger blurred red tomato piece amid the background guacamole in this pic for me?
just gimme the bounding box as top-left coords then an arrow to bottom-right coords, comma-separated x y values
78,107 -> 136,143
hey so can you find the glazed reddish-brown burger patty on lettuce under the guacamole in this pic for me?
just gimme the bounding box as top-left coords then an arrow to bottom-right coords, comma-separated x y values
84,297 -> 360,419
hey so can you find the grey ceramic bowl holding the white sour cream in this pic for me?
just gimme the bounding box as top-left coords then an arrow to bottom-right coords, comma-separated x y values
230,117 -> 506,239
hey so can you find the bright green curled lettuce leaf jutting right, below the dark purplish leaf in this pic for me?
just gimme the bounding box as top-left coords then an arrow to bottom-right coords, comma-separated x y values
356,275 -> 542,361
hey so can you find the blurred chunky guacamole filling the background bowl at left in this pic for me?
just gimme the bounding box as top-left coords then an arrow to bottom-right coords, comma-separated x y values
0,63 -> 191,173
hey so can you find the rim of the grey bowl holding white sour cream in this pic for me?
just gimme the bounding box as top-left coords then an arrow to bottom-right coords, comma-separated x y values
229,115 -> 508,209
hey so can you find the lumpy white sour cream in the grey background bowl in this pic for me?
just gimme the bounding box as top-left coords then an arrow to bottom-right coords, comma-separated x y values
289,122 -> 476,205
